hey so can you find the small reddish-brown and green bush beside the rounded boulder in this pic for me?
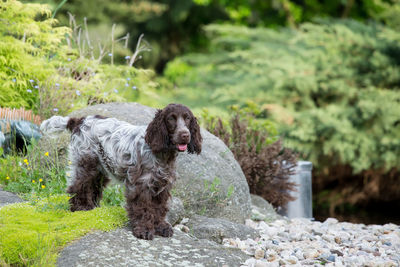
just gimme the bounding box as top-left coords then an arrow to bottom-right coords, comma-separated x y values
203,105 -> 296,209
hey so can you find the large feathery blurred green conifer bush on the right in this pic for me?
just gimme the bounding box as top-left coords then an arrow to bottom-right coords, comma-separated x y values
165,20 -> 400,211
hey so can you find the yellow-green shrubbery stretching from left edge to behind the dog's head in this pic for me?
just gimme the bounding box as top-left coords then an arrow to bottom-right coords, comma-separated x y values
0,0 -> 158,118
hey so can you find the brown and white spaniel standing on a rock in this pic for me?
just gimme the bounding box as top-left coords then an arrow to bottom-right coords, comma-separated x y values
41,104 -> 202,239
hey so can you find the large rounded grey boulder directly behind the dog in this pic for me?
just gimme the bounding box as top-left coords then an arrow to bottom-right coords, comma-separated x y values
41,103 -> 251,223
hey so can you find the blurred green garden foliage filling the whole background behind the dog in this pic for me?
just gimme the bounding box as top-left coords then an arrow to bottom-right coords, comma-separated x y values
0,0 -> 400,223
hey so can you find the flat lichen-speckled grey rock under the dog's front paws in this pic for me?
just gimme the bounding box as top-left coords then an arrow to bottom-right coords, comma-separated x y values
57,228 -> 250,267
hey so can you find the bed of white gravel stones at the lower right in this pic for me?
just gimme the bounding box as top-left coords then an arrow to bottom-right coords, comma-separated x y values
223,218 -> 400,267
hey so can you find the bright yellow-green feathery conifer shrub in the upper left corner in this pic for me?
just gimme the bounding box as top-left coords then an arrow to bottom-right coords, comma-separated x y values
0,0 -> 69,110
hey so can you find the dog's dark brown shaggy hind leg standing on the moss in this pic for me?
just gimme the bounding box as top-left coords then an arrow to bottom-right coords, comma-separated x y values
67,155 -> 109,211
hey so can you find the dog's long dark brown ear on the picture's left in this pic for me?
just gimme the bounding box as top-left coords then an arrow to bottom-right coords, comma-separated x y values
145,109 -> 169,153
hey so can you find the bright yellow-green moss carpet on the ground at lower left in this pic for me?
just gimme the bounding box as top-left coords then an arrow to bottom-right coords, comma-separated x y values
0,195 -> 126,266
